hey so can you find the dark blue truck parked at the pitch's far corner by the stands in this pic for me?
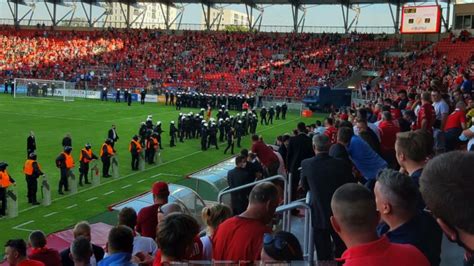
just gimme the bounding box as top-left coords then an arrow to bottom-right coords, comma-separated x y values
303,87 -> 352,112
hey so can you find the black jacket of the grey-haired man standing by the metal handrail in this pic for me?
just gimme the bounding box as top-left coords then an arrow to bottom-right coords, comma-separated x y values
301,153 -> 355,229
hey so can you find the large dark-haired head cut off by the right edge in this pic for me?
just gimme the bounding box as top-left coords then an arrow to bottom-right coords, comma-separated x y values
420,151 -> 474,265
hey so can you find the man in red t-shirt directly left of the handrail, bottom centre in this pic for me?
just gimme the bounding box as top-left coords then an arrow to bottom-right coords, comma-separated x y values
212,182 -> 279,262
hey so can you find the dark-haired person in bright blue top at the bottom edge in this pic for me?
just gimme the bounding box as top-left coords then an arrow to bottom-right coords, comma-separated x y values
99,225 -> 134,266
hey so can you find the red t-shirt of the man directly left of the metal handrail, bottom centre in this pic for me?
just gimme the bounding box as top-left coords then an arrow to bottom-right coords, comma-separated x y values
212,216 -> 272,261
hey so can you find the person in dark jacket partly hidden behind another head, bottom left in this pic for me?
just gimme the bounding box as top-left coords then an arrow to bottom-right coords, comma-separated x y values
61,222 -> 104,266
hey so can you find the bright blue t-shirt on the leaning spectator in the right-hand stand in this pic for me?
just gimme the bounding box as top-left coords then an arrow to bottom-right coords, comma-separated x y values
347,135 -> 387,180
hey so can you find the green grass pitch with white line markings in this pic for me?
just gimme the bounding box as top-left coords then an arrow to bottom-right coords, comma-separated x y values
0,95 -> 322,247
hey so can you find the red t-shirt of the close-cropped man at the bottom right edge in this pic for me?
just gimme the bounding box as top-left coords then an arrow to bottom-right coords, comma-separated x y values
338,237 -> 430,266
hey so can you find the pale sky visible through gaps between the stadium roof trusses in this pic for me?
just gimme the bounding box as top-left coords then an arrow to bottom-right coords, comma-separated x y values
0,0 -> 452,32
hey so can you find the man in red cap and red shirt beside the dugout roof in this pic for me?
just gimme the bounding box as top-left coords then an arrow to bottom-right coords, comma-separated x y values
135,182 -> 170,239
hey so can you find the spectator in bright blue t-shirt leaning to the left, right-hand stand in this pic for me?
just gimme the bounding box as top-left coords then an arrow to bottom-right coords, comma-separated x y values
337,127 -> 387,181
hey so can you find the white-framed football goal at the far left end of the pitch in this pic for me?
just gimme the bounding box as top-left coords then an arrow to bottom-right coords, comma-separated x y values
14,78 -> 75,102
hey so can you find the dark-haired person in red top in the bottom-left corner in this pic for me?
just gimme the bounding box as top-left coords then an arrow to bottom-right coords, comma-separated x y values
5,239 -> 45,266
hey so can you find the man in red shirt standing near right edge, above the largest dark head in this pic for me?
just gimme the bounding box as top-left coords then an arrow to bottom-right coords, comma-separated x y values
444,102 -> 466,151
